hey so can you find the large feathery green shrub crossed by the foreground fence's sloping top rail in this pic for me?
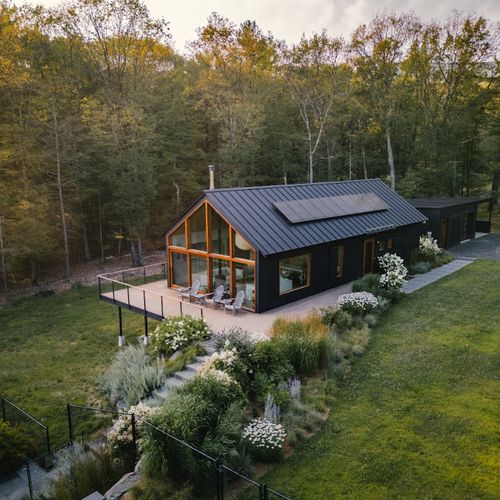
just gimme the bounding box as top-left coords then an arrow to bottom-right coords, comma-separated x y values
141,377 -> 246,490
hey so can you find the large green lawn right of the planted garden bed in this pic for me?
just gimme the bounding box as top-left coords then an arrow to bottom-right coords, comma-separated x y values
249,261 -> 500,500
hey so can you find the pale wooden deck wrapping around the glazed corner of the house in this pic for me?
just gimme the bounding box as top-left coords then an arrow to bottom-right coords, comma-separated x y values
100,280 -> 351,334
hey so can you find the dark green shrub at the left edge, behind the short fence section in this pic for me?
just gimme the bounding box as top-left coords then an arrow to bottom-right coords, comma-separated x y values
0,420 -> 37,477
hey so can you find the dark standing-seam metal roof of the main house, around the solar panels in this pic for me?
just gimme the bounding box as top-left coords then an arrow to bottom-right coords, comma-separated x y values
205,179 -> 426,255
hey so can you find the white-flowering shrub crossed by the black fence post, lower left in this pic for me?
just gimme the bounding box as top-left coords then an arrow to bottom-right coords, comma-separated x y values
107,403 -> 159,456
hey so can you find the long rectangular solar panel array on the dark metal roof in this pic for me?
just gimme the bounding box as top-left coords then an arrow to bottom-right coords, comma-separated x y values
273,192 -> 389,224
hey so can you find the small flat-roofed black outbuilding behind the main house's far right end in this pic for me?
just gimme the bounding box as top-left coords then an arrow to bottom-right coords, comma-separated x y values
410,197 -> 492,248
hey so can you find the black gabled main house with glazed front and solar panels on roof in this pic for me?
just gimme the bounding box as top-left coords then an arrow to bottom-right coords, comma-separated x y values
166,179 -> 425,312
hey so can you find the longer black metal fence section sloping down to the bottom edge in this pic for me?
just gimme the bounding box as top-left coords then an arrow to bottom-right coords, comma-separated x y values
67,404 -> 290,500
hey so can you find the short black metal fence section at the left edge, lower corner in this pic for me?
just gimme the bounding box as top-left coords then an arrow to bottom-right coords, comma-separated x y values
0,395 -> 50,460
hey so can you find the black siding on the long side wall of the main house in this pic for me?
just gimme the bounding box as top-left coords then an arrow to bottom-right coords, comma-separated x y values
257,224 -> 421,312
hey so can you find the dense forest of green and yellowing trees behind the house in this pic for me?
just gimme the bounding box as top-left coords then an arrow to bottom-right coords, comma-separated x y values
0,0 -> 500,291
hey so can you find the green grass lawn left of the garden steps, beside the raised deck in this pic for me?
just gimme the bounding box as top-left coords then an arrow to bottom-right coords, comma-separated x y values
0,288 -> 158,446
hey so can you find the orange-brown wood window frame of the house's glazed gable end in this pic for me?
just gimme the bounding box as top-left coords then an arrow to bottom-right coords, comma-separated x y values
165,200 -> 258,311
